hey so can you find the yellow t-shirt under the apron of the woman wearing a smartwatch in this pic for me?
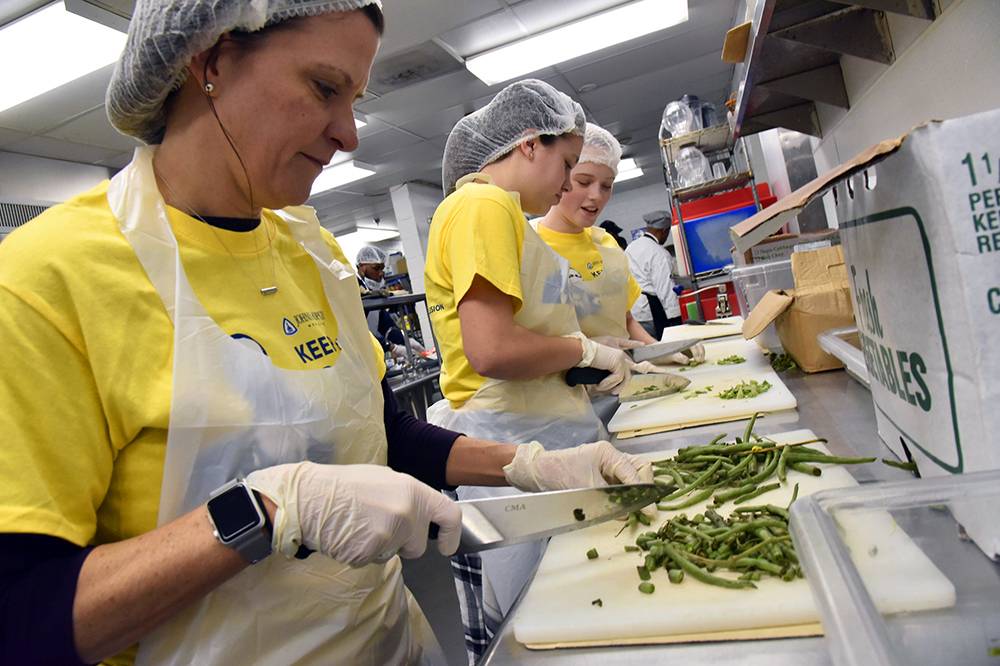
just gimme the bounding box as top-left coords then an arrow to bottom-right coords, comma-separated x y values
0,182 -> 384,663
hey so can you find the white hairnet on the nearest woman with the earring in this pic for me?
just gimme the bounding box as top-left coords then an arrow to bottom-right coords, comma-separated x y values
106,0 -> 382,144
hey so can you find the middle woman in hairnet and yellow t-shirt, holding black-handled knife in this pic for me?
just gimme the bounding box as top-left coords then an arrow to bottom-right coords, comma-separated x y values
425,79 -> 650,661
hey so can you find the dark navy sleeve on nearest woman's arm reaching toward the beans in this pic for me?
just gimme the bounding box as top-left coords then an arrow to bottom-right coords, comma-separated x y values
382,379 -> 460,490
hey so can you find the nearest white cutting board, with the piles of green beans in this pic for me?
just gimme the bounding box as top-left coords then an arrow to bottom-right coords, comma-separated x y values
513,430 -> 955,647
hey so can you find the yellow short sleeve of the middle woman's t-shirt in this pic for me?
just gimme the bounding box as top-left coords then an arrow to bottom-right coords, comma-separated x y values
440,193 -> 526,312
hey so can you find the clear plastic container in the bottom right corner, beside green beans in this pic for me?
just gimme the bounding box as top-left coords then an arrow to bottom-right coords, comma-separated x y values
791,470 -> 1000,666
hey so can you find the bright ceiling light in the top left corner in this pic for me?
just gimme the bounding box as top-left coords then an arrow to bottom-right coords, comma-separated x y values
0,2 -> 126,111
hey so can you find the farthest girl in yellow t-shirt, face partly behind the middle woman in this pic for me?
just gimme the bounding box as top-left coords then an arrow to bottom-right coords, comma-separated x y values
532,123 -> 704,422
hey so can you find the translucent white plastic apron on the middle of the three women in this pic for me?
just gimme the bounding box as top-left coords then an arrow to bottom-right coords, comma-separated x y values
427,175 -> 607,614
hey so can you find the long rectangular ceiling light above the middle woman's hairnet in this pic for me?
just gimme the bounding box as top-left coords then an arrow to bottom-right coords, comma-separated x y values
465,0 -> 688,85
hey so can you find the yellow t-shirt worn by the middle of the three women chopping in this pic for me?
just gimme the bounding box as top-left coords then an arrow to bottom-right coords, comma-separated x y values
424,183 -> 527,407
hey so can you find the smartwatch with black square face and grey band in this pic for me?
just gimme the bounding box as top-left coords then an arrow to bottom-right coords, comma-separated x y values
208,478 -> 273,564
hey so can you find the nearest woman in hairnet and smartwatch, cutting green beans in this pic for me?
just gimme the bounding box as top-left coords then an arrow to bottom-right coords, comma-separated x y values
0,0 -> 638,666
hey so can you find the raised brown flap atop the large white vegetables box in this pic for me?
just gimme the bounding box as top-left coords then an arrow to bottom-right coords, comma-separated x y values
729,125 -> 923,253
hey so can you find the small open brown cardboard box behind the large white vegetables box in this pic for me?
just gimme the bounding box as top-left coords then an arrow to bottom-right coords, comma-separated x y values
743,246 -> 854,372
